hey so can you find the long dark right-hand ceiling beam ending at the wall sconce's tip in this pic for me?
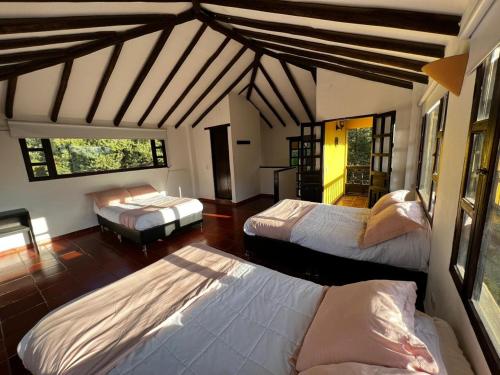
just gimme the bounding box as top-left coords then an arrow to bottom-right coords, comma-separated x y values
260,42 -> 429,84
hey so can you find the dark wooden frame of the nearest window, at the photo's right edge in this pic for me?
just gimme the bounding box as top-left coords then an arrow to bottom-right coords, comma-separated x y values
449,49 -> 500,373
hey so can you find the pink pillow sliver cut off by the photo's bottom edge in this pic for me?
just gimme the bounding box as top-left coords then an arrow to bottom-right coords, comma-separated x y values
299,362 -> 427,375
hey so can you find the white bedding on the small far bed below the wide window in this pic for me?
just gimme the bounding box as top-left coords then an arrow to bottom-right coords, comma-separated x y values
94,193 -> 203,230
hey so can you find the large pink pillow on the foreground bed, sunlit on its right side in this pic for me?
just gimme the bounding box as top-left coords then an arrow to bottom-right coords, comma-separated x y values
296,280 -> 438,374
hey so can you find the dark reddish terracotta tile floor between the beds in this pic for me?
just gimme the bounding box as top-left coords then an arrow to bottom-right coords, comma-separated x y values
0,197 -> 273,375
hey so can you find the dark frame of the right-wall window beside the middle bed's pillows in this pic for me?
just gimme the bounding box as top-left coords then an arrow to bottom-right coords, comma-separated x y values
415,93 -> 449,226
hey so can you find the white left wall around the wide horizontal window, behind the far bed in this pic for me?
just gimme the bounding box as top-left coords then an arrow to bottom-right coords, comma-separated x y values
0,130 -> 193,250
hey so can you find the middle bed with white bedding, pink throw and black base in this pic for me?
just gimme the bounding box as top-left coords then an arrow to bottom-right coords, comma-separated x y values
243,199 -> 431,307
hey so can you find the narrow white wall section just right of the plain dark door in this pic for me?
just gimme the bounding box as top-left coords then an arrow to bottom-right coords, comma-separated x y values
229,94 -> 261,202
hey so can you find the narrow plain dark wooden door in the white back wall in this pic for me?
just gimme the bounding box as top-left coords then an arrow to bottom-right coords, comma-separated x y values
210,125 -> 233,199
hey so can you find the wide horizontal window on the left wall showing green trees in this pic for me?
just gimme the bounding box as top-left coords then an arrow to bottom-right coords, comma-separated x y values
19,138 -> 167,181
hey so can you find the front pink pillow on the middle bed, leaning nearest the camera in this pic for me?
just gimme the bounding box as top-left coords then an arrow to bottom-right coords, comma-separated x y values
359,202 -> 426,249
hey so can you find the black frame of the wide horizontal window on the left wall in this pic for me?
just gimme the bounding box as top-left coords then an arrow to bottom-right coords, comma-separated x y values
19,137 -> 169,182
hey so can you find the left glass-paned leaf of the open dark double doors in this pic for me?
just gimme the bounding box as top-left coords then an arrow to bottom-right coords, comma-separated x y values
297,122 -> 325,202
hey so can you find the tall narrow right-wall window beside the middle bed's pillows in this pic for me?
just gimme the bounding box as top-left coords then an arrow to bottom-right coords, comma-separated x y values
417,95 -> 448,222
